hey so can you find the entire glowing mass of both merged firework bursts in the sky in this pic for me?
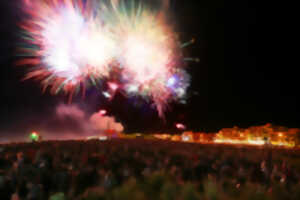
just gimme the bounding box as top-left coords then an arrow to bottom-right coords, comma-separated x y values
20,0 -> 189,117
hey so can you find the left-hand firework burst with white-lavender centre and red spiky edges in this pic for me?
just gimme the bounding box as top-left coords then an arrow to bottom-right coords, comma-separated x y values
22,0 -> 116,96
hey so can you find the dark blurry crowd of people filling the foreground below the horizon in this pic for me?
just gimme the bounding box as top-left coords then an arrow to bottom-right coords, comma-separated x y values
0,139 -> 300,200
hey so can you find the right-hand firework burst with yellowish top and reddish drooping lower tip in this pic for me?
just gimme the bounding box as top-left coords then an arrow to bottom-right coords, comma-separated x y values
106,0 -> 187,117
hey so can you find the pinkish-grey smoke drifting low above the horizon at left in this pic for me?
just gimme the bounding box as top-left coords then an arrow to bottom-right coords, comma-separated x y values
0,104 -> 124,143
